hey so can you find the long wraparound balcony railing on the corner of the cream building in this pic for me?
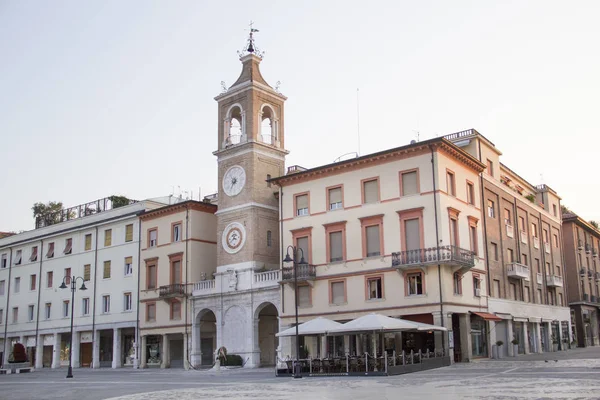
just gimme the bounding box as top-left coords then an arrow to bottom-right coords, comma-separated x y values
392,246 -> 475,267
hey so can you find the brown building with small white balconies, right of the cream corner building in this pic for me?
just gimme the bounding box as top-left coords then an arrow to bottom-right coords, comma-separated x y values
446,129 -> 571,355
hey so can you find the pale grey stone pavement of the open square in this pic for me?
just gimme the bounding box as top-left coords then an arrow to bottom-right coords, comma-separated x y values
0,348 -> 600,400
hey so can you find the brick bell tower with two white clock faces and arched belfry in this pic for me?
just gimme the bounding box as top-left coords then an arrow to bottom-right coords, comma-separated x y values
213,27 -> 288,272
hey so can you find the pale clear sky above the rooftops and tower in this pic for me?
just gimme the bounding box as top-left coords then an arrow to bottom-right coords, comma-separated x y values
0,0 -> 600,231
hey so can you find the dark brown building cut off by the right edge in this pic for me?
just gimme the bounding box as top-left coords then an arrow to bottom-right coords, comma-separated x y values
562,213 -> 600,347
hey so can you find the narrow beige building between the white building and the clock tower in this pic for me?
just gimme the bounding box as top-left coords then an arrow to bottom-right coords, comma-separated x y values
139,200 -> 217,368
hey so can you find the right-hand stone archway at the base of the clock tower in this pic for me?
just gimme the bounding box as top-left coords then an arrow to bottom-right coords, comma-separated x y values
255,302 -> 279,367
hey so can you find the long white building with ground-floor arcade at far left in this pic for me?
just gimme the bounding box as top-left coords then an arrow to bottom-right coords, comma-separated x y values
0,198 -> 166,368
